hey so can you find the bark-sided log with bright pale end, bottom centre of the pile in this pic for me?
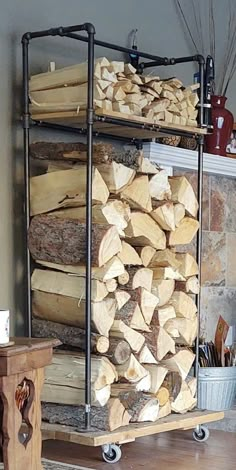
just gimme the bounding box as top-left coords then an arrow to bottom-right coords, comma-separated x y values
119,391 -> 159,423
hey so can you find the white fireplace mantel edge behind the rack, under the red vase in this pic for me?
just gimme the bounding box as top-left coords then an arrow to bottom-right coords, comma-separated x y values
143,142 -> 236,177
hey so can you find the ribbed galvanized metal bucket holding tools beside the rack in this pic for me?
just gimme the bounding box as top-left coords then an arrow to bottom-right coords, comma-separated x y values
198,367 -> 236,411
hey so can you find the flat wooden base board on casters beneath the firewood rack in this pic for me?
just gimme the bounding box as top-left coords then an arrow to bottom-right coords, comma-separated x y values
42,411 -> 224,447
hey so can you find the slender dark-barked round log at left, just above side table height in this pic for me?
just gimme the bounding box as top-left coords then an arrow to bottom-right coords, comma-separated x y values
32,318 -> 111,354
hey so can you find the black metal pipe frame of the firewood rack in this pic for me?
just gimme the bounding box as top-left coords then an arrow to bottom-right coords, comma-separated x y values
22,23 -> 204,431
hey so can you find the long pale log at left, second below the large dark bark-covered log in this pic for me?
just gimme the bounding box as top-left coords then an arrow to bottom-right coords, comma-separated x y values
31,269 -> 108,302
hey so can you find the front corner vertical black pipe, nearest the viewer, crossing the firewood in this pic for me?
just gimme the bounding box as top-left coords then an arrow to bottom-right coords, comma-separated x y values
85,28 -> 95,429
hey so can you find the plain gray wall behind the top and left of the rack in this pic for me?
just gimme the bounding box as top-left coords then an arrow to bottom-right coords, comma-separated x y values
0,0 -> 236,332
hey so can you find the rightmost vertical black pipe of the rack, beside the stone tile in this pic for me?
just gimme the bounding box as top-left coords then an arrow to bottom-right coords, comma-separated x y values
195,60 -> 204,404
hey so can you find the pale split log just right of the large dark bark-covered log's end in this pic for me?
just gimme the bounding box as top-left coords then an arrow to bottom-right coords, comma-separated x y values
125,212 -> 166,250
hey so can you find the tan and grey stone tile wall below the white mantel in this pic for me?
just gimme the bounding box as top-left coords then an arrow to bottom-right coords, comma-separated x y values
174,168 -> 236,341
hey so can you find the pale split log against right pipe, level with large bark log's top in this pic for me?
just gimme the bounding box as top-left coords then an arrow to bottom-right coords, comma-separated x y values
168,217 -> 199,246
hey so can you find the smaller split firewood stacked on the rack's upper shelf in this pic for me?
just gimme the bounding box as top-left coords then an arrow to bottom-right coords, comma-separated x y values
30,57 -> 199,126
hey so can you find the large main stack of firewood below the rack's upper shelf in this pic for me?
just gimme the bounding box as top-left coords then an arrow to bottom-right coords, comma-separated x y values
28,142 -> 199,430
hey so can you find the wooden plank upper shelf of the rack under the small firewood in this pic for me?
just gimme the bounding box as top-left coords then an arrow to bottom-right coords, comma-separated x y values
32,110 -> 207,139
